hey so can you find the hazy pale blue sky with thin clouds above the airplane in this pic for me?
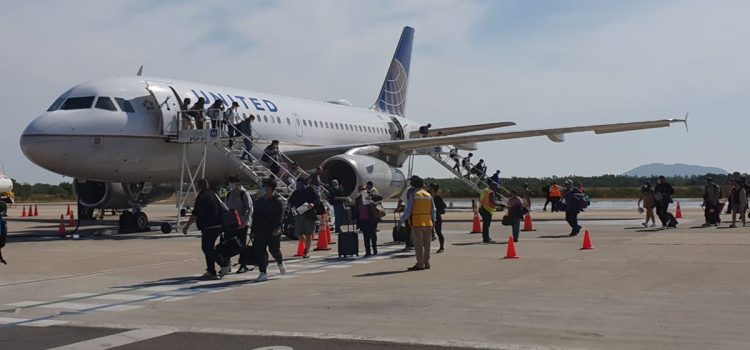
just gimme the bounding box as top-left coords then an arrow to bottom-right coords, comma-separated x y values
0,0 -> 750,183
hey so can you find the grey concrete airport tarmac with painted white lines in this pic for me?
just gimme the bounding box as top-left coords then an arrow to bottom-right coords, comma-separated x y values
0,204 -> 750,350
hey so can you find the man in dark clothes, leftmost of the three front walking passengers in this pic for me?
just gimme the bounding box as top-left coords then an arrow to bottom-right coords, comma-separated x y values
182,179 -> 229,278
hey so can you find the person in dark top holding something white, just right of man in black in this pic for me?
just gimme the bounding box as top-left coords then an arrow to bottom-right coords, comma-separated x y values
289,178 -> 320,258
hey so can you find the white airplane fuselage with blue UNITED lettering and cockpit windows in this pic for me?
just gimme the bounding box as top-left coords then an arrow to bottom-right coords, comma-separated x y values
21,77 -> 418,183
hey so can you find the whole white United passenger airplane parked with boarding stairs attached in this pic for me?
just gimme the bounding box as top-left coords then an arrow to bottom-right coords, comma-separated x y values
20,26 -> 687,229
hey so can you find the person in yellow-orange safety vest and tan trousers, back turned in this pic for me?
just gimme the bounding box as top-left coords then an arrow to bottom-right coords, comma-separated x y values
399,175 -> 436,271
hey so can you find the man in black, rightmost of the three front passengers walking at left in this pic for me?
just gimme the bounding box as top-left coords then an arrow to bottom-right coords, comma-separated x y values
250,179 -> 286,282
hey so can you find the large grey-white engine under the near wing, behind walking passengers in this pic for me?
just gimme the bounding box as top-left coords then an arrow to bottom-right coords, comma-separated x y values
321,154 -> 406,198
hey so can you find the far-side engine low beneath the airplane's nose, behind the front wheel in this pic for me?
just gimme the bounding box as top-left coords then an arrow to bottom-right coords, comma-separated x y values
73,180 -> 174,209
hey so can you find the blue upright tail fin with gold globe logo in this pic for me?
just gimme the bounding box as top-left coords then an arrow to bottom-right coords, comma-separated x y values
372,26 -> 414,117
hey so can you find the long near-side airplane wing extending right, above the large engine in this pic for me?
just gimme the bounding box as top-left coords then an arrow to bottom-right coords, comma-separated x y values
284,119 -> 687,162
